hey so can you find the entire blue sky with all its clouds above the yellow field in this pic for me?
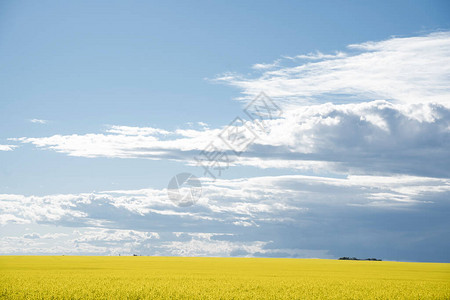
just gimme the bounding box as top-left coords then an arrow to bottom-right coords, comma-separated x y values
0,1 -> 450,262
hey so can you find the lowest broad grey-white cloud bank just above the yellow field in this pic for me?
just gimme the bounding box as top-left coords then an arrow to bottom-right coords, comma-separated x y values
0,175 -> 450,260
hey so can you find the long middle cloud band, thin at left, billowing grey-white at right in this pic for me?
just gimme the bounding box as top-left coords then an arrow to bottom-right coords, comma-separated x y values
10,100 -> 450,177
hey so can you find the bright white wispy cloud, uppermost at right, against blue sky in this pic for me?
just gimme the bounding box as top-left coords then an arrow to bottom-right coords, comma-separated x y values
216,32 -> 450,107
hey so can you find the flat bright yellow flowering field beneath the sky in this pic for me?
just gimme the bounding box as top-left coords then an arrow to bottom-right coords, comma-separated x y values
0,256 -> 450,299
